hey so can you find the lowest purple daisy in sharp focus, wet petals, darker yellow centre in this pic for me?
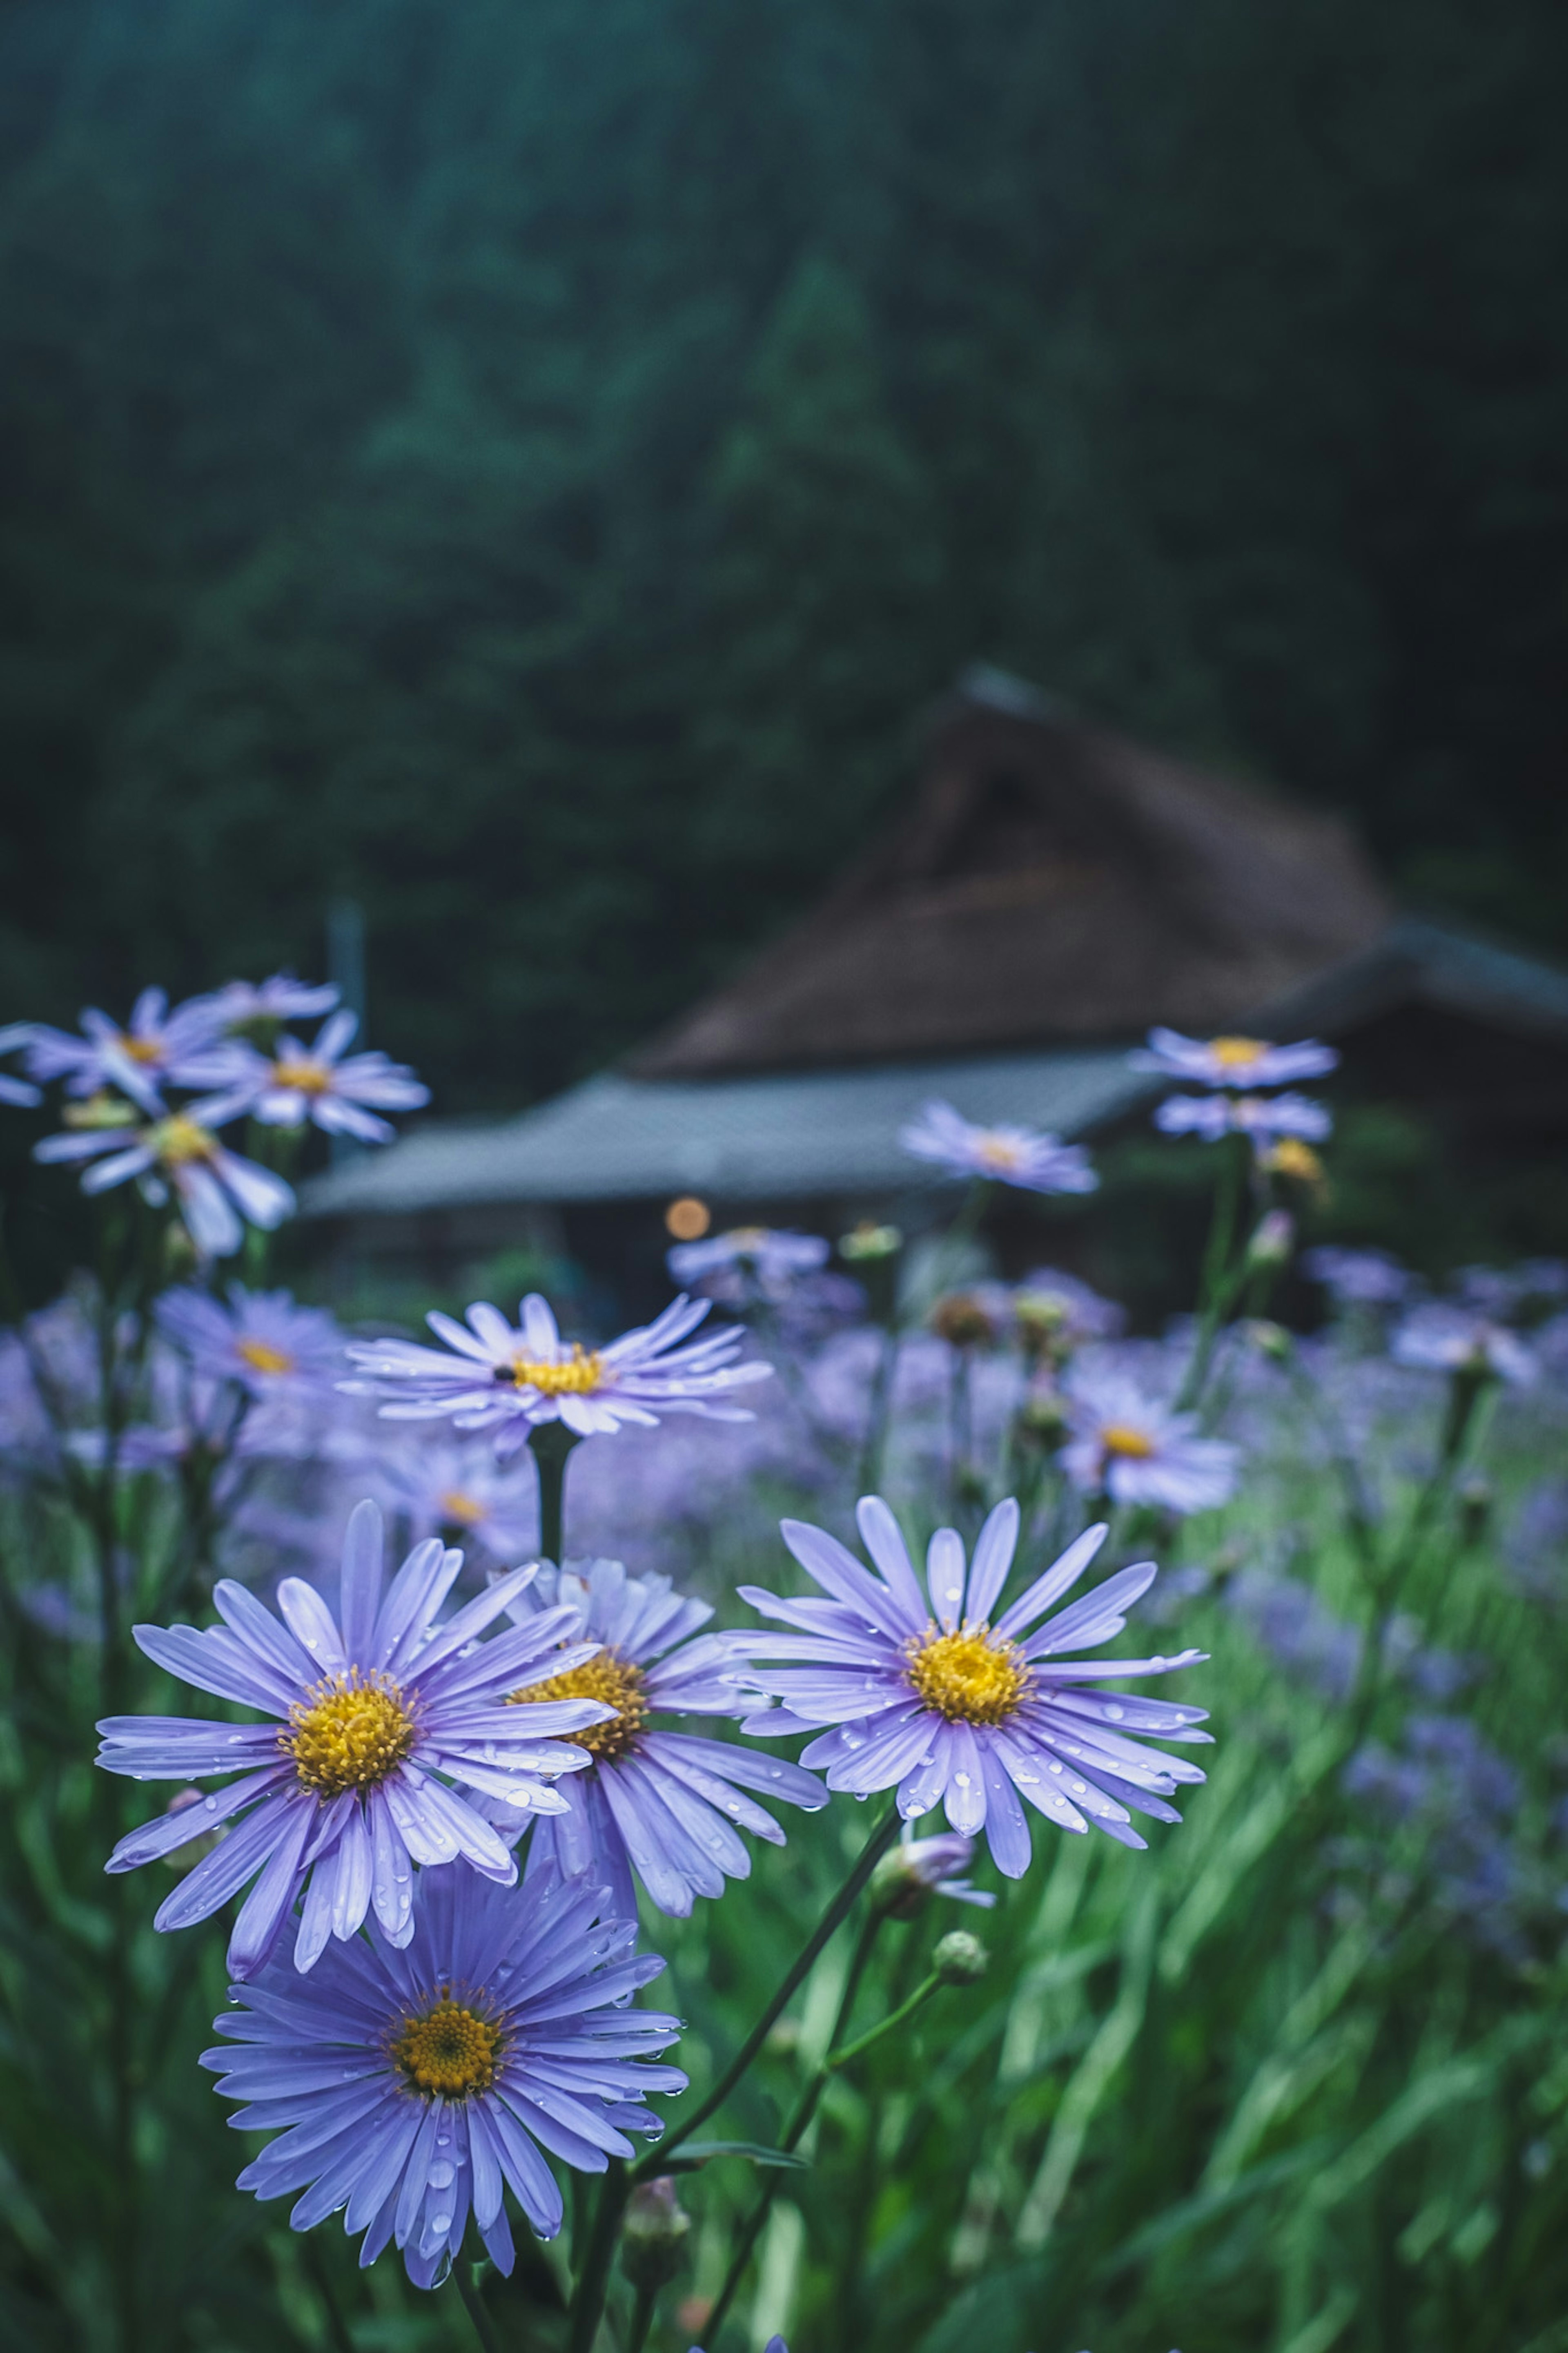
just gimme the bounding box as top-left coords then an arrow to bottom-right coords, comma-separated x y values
202,1864 -> 686,2287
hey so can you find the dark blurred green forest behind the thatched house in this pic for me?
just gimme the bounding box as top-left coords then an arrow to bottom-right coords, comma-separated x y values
0,0 -> 1568,1108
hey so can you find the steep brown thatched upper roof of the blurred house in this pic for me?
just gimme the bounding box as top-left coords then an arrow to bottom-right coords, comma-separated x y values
628,671 -> 1389,1078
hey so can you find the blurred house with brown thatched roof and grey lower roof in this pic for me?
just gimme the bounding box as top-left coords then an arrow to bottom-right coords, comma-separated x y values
308,671 -> 1568,1264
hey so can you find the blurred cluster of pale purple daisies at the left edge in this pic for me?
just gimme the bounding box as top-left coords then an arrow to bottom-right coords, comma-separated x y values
0,972 -> 430,1259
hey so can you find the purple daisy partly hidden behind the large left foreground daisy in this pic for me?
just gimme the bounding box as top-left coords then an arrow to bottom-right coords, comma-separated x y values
508,1560 -> 828,1920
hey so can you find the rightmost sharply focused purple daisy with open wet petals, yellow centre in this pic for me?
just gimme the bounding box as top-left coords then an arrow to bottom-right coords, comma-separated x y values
740,1497 -> 1208,1880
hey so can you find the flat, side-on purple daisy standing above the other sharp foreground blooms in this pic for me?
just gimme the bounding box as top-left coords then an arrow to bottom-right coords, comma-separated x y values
341,1292 -> 773,1454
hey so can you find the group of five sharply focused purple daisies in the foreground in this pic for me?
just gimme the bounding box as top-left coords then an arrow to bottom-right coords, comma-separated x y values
101,1301 -> 1206,2287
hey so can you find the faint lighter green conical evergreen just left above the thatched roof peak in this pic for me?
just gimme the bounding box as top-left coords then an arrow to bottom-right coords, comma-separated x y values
691,256 -> 947,925
